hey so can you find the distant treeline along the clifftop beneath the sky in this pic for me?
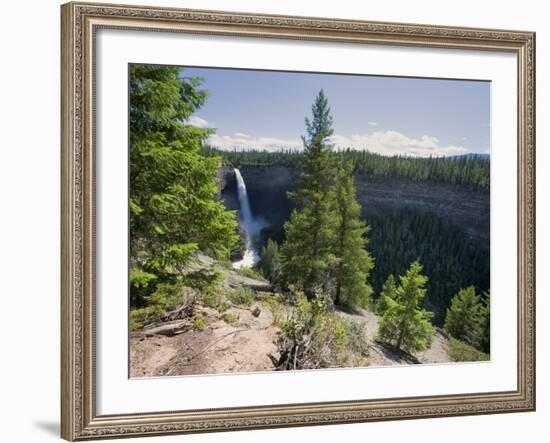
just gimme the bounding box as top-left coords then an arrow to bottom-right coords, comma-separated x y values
203,146 -> 491,191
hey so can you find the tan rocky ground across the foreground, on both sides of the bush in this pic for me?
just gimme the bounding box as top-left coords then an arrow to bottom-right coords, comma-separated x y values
130,256 -> 451,377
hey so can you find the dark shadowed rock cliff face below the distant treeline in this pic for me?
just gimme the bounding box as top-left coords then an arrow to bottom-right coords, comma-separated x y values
220,166 -> 490,250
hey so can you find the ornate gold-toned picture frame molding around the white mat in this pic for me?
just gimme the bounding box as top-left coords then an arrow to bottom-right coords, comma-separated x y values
61,2 -> 535,441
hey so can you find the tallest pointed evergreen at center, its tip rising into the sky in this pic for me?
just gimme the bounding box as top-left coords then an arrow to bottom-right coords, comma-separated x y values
282,90 -> 336,297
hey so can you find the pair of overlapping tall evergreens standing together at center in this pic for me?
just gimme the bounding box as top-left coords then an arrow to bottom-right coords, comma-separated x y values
282,90 -> 374,307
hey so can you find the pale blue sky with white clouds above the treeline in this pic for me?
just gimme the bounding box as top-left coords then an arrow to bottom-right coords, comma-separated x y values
182,68 -> 490,156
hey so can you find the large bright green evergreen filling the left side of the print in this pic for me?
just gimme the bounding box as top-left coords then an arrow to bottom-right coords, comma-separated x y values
130,65 -> 237,307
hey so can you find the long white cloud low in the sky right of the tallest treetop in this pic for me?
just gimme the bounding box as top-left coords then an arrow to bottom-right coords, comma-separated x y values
331,131 -> 470,157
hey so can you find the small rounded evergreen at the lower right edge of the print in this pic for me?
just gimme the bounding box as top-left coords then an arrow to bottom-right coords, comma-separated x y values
445,286 -> 487,348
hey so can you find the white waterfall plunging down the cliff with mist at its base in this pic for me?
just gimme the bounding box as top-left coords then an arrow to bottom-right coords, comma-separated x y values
233,168 -> 266,269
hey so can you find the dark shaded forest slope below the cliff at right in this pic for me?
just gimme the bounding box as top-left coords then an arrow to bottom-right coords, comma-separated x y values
367,209 -> 490,326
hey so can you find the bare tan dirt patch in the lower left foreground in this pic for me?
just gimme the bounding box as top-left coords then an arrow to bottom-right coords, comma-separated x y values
131,306 -> 279,377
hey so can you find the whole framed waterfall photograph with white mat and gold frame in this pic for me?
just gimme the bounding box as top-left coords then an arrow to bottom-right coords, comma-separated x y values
61,2 -> 535,441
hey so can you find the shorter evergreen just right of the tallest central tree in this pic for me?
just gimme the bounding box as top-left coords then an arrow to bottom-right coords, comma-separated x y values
334,162 -> 374,307
